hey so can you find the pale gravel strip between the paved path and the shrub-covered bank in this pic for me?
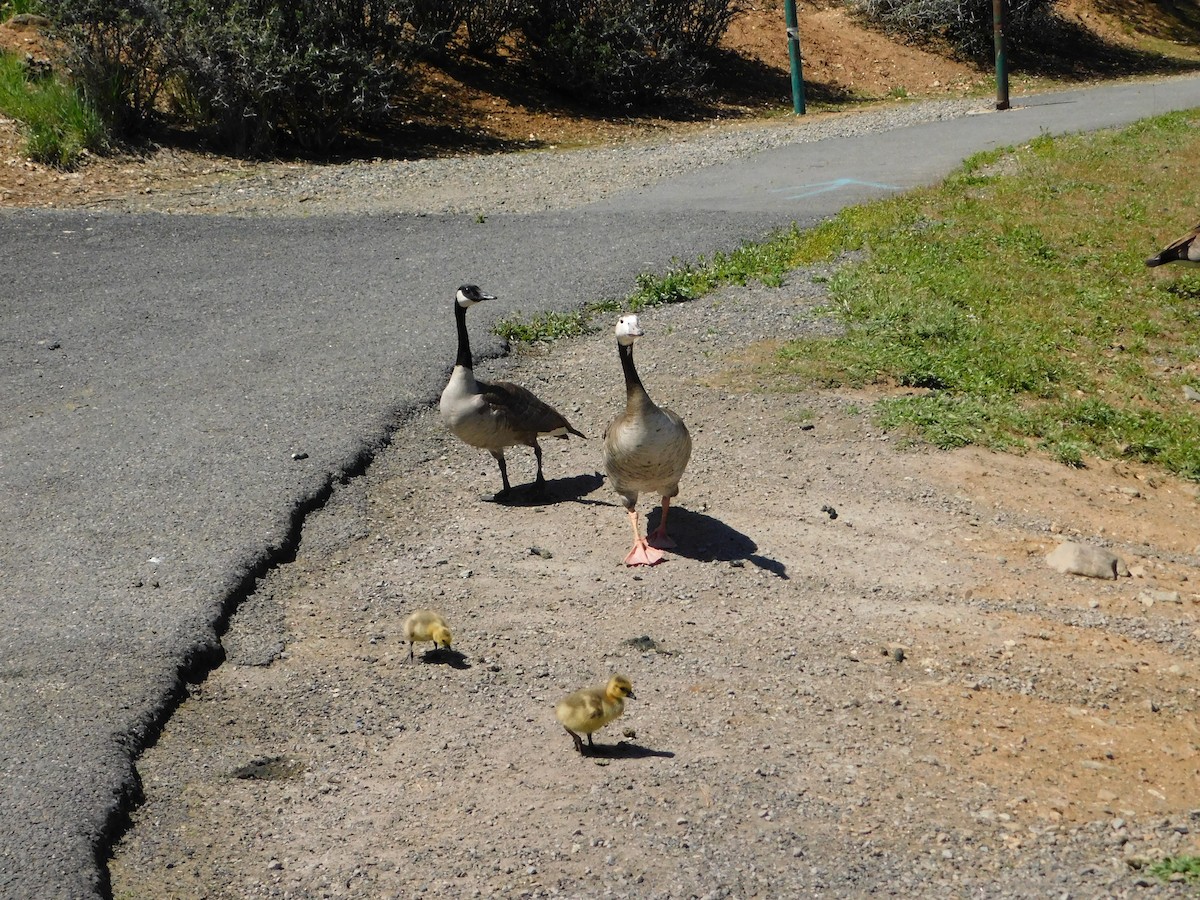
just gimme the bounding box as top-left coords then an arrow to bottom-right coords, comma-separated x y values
138,100 -> 990,216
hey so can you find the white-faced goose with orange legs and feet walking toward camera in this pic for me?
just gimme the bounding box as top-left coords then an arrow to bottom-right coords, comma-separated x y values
604,316 -> 691,565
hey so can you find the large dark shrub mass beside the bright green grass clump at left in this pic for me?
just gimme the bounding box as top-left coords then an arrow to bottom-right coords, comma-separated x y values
44,0 -> 412,154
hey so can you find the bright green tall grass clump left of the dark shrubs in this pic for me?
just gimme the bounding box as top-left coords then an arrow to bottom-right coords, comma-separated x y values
0,53 -> 107,169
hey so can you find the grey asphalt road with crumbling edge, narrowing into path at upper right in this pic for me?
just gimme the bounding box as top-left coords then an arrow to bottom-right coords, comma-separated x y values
7,78 -> 1200,900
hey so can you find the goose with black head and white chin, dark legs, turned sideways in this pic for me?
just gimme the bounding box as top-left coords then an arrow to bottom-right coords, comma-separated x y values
440,284 -> 586,496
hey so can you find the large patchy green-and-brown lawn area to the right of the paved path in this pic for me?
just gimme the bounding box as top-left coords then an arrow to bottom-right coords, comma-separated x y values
762,112 -> 1200,480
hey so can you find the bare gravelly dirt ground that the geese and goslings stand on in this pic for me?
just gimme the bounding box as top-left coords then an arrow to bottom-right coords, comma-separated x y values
112,272 -> 1200,899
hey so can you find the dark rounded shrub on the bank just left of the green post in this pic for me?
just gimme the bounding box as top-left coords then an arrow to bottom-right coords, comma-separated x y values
521,0 -> 737,104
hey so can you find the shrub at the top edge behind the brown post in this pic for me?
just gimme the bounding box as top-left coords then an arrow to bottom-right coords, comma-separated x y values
851,0 -> 1055,60
